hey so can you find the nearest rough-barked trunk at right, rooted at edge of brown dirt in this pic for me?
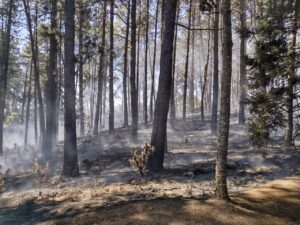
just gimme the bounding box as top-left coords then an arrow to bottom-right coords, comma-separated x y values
215,0 -> 232,200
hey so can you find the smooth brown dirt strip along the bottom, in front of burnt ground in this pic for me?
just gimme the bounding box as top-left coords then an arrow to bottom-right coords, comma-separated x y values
58,177 -> 300,225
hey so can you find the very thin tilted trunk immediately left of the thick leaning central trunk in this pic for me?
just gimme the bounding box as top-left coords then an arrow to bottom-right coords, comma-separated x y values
150,2 -> 159,121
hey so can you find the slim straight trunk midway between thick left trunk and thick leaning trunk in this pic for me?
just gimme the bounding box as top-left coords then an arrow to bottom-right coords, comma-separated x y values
108,0 -> 115,133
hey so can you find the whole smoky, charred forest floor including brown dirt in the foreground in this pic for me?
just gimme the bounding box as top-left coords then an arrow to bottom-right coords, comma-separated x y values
0,118 -> 300,225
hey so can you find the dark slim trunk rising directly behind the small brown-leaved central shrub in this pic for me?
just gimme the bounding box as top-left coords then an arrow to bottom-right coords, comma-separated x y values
130,0 -> 138,137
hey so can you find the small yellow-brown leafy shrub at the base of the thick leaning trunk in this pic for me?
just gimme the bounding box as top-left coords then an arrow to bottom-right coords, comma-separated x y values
131,142 -> 154,177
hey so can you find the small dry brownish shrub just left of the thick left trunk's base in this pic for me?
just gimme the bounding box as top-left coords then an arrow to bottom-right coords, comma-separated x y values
32,160 -> 50,185
